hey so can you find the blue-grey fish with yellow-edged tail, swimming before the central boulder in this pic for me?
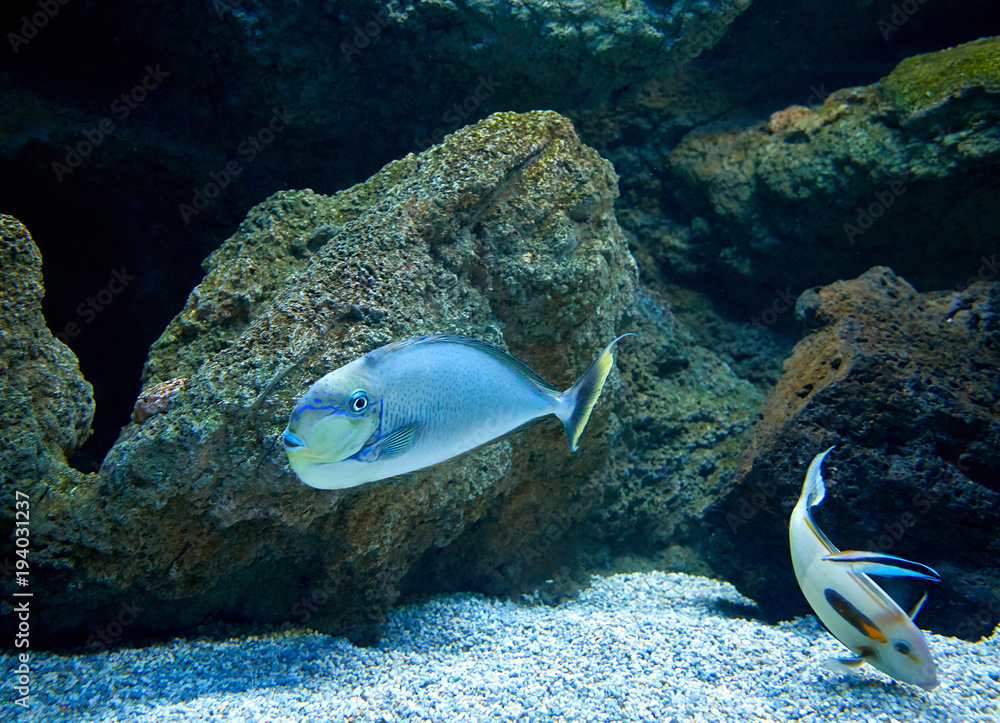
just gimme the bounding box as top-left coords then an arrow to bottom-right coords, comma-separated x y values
282,334 -> 629,489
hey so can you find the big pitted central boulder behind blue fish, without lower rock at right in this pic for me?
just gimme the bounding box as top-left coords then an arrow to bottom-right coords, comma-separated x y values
1,113 -> 624,642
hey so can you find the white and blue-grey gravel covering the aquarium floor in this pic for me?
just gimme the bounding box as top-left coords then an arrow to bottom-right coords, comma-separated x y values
2,572 -> 1000,723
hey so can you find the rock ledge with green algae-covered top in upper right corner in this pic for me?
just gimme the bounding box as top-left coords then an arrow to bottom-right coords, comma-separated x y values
640,38 -> 1000,310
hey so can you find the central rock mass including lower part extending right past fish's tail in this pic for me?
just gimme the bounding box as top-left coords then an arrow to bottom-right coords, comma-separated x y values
0,112 -> 758,645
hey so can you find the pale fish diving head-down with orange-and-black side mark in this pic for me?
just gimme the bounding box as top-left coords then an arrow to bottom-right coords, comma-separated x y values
788,447 -> 941,690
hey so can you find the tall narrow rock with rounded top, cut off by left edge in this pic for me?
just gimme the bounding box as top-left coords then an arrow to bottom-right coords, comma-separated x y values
0,215 -> 97,628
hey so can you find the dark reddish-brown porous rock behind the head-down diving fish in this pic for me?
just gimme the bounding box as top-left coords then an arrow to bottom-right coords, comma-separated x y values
704,267 -> 1000,639
